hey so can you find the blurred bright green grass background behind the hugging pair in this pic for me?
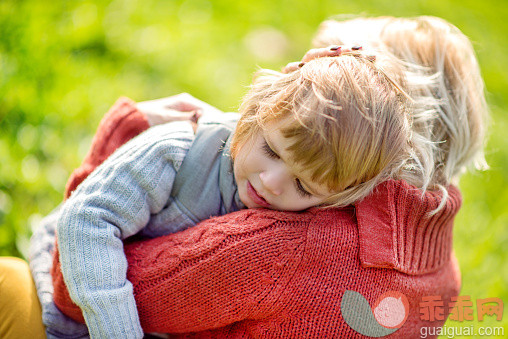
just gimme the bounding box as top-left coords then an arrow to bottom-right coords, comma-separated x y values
0,0 -> 508,335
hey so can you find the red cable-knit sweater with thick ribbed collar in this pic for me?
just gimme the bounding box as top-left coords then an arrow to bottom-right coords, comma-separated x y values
53,99 -> 461,338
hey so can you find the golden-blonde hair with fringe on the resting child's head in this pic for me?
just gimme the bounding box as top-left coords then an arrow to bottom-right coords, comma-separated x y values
231,53 -> 411,206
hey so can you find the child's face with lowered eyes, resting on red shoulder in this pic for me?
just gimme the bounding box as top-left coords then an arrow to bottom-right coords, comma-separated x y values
234,122 -> 333,211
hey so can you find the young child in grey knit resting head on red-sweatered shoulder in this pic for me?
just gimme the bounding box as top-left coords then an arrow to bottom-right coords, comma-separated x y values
57,51 -> 411,338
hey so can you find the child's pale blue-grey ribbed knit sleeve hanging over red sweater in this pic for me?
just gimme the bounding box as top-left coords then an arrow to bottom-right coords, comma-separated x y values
57,122 -> 194,338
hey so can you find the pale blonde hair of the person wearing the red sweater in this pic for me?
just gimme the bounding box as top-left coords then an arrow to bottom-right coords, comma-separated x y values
313,16 -> 488,197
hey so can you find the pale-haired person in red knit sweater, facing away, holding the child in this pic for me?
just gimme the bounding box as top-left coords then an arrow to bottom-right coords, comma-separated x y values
0,14 -> 486,337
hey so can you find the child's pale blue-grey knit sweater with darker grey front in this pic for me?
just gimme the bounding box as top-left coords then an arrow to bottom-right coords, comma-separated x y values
33,114 -> 244,338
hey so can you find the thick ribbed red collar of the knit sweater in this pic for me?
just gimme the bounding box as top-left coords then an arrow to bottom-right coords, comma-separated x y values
355,181 -> 462,275
